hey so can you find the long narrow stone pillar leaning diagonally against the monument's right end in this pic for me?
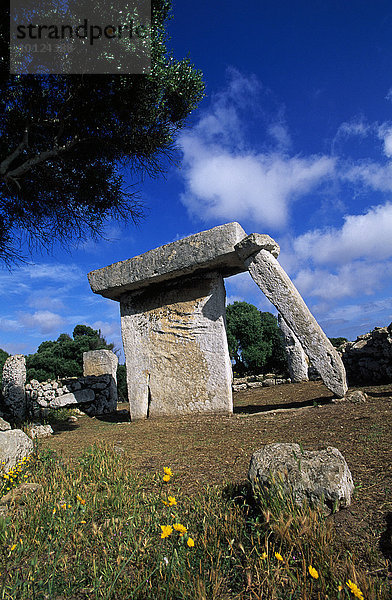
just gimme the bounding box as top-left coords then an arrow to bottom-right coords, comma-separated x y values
238,242 -> 347,398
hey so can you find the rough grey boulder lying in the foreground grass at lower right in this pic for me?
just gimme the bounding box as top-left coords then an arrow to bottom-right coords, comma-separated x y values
248,444 -> 354,511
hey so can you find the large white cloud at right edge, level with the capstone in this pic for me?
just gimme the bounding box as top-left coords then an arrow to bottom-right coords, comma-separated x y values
294,203 -> 392,264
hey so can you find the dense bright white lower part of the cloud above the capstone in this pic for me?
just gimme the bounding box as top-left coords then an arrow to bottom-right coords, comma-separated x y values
182,145 -> 334,229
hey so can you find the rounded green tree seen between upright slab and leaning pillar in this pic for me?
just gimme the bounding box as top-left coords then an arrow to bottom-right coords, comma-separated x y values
226,302 -> 287,375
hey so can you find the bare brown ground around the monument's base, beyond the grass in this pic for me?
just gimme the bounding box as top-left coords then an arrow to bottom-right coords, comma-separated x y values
41,382 -> 392,577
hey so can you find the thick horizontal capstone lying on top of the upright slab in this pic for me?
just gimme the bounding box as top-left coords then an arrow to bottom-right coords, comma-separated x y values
88,223 -> 247,300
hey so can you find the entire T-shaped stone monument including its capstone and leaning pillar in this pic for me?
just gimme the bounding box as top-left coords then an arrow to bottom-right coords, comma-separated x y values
88,223 -> 347,419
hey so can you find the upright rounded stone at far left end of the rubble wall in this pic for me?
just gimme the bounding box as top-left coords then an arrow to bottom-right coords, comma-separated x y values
2,354 -> 27,421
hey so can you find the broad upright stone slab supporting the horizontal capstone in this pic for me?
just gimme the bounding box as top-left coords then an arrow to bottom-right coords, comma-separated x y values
121,273 -> 232,419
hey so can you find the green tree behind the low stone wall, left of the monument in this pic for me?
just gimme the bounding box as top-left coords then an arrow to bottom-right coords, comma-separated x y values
26,325 -> 113,381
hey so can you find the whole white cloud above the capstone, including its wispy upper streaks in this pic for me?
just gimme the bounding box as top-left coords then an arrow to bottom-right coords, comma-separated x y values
179,71 -> 335,229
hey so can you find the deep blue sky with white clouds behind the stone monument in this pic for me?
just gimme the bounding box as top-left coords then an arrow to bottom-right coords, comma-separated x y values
0,0 -> 392,354
